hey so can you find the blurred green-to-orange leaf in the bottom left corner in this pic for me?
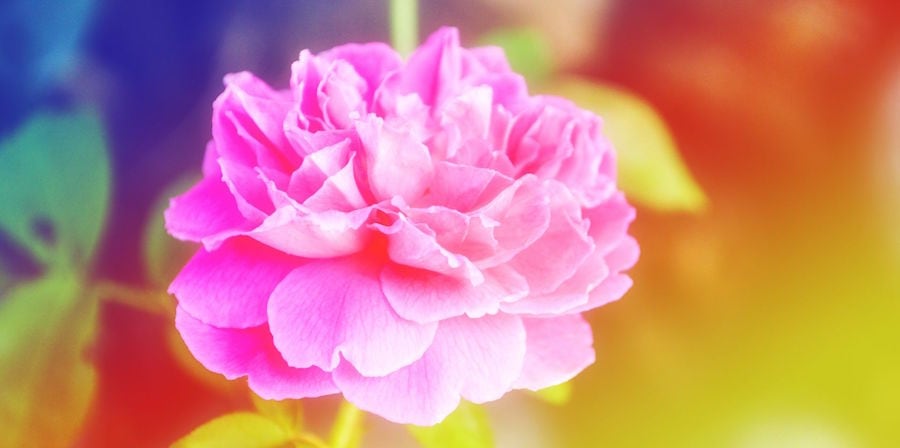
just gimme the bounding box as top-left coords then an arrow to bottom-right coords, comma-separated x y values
0,270 -> 97,447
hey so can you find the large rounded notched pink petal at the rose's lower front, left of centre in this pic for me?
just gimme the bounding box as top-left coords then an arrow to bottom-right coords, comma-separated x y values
269,256 -> 437,376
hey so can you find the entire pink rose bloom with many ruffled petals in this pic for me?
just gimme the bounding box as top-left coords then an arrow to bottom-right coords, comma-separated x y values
166,28 -> 638,425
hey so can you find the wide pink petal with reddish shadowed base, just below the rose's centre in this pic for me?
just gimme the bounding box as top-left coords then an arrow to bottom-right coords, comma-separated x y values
381,264 -> 528,323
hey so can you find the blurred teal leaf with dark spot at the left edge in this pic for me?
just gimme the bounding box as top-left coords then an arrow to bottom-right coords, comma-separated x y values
0,112 -> 110,266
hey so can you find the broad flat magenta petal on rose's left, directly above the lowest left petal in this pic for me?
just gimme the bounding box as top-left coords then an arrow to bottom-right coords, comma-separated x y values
169,238 -> 303,328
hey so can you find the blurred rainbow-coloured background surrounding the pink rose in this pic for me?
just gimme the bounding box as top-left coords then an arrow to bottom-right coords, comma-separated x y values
0,0 -> 900,448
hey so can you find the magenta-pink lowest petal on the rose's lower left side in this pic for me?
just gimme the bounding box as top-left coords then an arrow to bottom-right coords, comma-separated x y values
175,307 -> 338,400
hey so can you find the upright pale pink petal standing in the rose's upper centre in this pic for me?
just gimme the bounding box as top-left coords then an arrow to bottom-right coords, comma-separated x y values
356,117 -> 434,204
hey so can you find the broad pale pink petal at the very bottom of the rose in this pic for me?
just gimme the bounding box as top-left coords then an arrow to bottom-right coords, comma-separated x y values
334,314 -> 525,426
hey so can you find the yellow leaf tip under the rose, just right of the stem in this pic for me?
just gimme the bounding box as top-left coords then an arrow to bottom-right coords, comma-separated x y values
407,401 -> 494,448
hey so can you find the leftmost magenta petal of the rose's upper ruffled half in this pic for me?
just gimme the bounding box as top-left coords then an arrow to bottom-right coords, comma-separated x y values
166,177 -> 247,242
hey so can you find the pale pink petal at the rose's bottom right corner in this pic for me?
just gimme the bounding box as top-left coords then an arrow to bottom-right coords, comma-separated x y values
515,314 -> 595,390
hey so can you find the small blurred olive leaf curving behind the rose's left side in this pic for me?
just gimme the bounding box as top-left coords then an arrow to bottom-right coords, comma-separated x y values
144,176 -> 198,289
